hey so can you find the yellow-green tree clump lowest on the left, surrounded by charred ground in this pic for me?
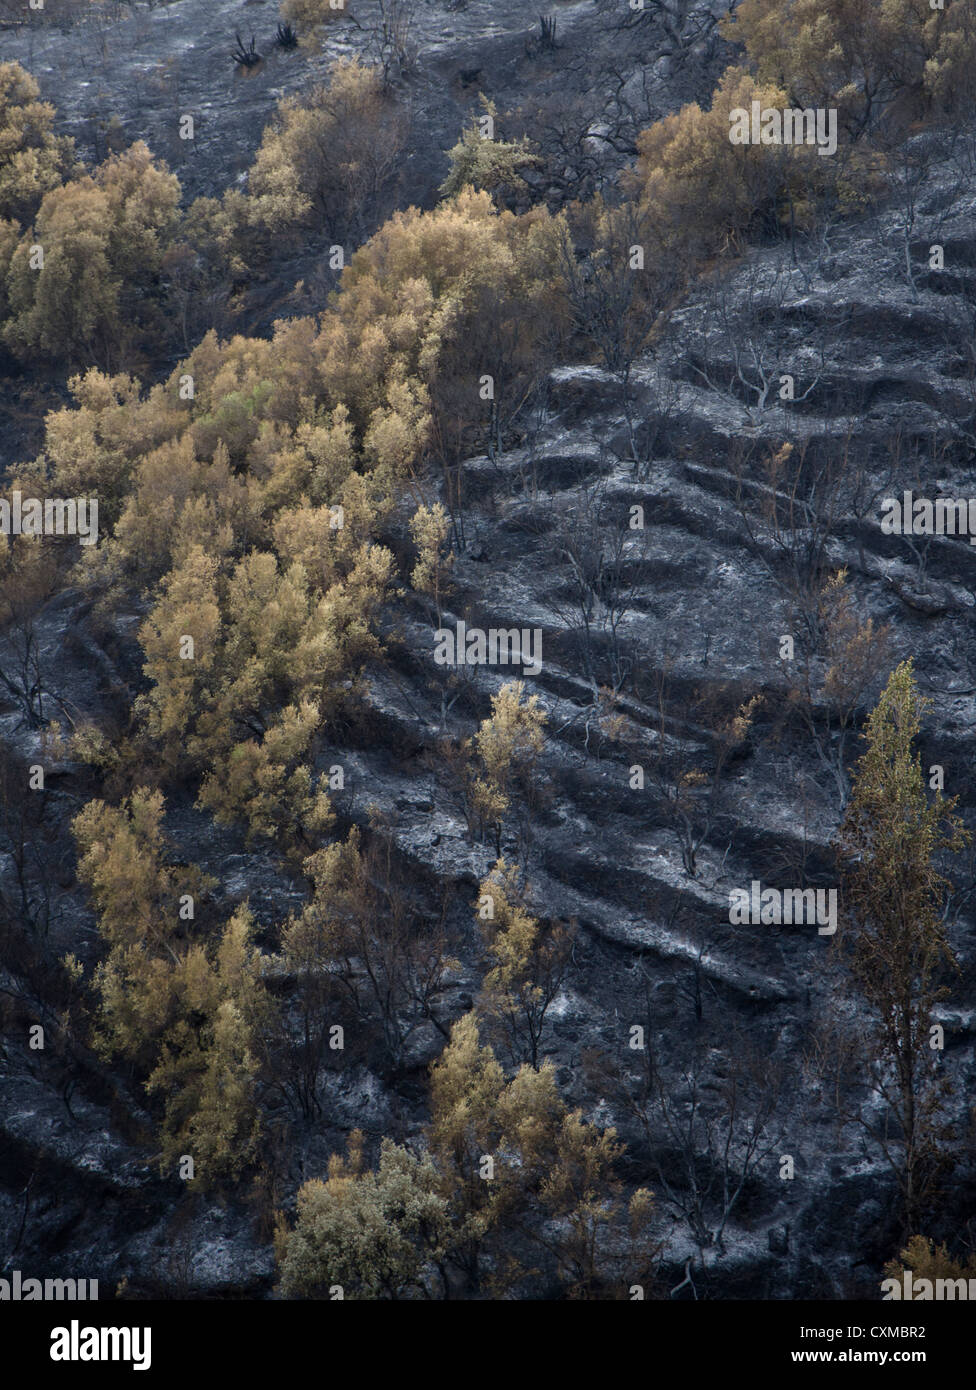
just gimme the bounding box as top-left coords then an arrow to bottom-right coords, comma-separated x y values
72,788 -> 270,1187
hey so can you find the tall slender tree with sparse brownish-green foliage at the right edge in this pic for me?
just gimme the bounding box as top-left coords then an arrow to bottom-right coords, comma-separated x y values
838,660 -> 969,1230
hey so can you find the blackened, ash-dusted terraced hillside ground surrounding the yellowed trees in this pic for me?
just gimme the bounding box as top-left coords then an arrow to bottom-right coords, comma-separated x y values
0,0 -> 976,1300
